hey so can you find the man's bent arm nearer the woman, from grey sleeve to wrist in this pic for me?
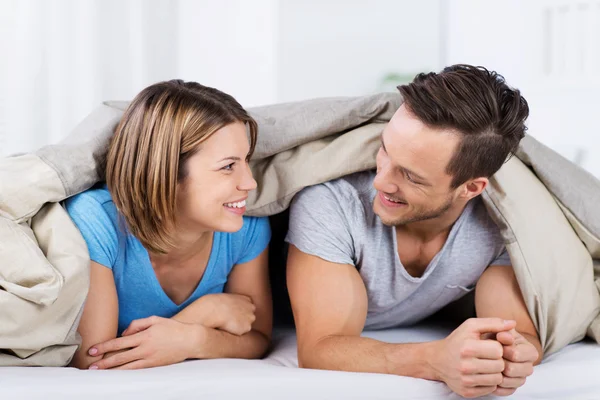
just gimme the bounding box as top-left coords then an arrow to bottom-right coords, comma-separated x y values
287,245 -> 434,379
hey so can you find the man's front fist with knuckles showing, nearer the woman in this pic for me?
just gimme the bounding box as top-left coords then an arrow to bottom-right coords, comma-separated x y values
431,318 -> 516,397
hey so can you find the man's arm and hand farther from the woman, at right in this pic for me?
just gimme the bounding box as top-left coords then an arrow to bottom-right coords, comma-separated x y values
475,265 -> 544,395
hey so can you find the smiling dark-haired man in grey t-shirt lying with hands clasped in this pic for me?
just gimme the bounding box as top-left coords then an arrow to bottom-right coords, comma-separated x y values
286,65 -> 542,397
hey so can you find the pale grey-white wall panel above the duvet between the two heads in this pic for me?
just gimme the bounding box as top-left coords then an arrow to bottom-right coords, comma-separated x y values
277,0 -> 444,101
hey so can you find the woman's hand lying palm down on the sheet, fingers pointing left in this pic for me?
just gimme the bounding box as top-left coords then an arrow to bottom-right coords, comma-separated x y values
88,316 -> 202,369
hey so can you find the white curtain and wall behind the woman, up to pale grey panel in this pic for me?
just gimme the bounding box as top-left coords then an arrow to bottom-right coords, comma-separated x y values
0,0 -> 277,155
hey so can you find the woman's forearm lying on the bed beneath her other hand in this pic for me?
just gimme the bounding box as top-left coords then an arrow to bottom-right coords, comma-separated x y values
190,325 -> 269,359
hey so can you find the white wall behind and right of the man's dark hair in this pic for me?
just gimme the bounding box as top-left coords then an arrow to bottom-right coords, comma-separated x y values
447,0 -> 600,176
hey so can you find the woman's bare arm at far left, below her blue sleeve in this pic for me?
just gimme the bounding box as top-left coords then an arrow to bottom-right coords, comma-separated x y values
71,261 -> 119,369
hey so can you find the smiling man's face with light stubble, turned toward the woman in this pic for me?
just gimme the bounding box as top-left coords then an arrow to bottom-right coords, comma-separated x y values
373,105 -> 460,226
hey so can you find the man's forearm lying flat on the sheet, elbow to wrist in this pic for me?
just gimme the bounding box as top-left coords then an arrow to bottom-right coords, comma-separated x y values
299,336 -> 439,380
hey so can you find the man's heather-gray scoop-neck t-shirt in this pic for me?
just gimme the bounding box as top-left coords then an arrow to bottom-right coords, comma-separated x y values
286,171 -> 511,329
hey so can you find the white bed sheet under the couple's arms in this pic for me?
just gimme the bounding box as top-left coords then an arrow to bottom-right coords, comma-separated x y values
0,326 -> 600,400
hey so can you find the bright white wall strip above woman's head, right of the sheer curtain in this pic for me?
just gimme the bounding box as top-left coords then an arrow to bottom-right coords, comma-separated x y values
177,0 -> 278,107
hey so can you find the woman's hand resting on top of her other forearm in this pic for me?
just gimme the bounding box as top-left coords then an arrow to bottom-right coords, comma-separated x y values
173,293 -> 256,336
